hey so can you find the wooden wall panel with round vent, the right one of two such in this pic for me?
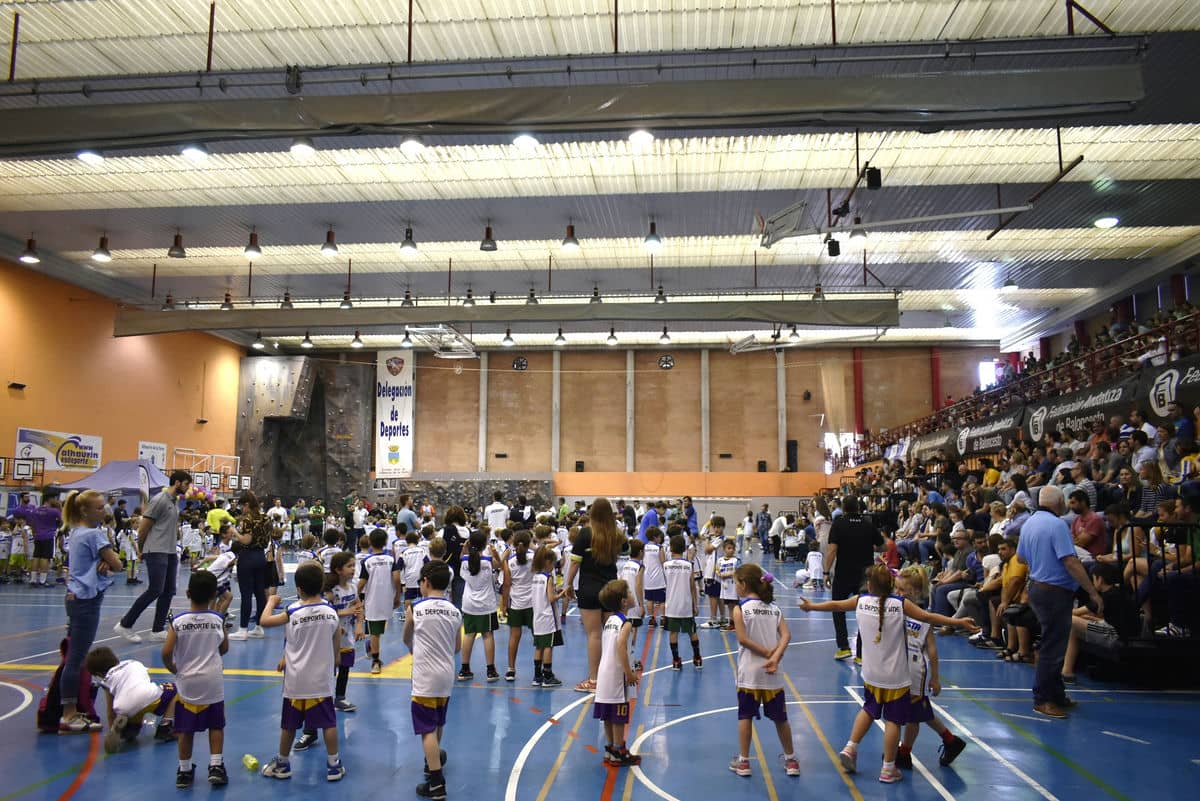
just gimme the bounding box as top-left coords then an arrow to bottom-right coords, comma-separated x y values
634,349 -> 701,471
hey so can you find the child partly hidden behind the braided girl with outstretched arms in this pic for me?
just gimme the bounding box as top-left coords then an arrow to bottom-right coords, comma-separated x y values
896,565 -> 967,770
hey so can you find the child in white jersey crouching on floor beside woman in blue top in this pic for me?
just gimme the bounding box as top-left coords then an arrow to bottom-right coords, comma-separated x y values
84,646 -> 175,754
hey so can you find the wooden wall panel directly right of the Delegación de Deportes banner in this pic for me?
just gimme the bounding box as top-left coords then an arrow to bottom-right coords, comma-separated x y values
413,354 -> 479,472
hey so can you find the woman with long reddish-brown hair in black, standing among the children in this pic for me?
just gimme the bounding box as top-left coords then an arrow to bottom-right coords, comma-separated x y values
564,498 -> 625,693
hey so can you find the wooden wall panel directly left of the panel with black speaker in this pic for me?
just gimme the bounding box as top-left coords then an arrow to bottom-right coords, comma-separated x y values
708,350 -> 779,472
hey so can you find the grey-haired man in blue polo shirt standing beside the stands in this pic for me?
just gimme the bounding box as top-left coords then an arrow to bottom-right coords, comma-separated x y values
1016,487 -> 1104,719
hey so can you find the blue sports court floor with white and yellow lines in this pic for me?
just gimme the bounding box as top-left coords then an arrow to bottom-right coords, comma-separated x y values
0,551 -> 1200,801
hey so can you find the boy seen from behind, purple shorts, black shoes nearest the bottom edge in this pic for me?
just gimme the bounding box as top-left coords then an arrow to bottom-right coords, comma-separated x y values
403,560 -> 462,799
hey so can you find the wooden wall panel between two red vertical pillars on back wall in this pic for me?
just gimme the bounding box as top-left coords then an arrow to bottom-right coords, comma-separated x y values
863,348 -> 944,432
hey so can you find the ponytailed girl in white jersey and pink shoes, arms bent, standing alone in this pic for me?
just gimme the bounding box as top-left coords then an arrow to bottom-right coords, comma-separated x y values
730,564 -> 800,776
